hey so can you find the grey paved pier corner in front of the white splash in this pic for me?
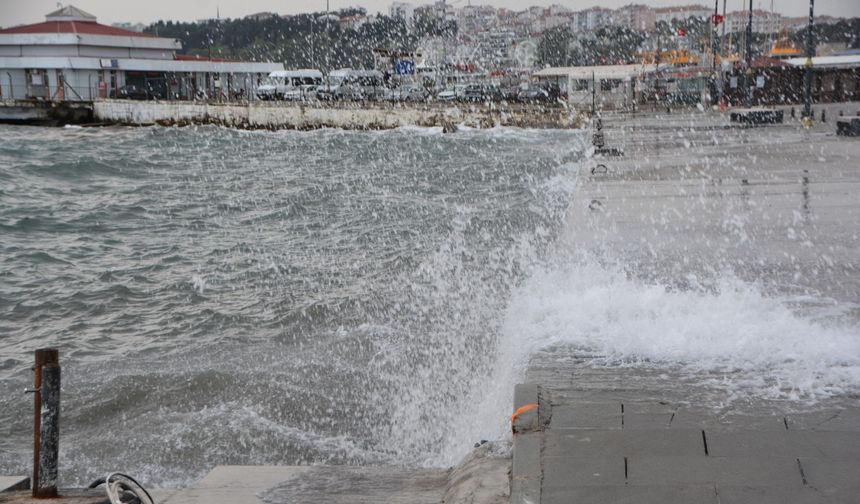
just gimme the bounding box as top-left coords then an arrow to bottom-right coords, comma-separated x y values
512,348 -> 860,504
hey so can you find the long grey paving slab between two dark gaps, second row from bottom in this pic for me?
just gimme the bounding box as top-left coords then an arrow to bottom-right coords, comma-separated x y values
627,454 -> 803,488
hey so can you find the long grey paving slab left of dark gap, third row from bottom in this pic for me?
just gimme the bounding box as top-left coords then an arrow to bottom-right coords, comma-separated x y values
543,429 -> 705,458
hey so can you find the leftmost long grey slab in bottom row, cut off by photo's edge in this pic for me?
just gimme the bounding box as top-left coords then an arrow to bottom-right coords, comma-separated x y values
541,485 -> 721,504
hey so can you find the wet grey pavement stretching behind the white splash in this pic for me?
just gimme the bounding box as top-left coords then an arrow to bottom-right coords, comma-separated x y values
568,106 -> 860,308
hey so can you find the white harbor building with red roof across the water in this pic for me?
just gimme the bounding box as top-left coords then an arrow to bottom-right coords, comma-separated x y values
0,5 -> 284,102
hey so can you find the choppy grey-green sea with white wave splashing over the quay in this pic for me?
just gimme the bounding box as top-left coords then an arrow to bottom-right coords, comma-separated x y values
0,123 -> 860,486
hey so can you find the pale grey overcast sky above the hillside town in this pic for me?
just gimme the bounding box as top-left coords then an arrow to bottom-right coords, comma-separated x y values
0,0 -> 860,27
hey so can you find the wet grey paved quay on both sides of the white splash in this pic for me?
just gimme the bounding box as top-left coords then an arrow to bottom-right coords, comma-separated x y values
6,103 -> 860,504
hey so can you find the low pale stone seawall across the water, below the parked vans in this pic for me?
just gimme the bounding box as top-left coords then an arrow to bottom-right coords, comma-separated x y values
93,100 -> 583,130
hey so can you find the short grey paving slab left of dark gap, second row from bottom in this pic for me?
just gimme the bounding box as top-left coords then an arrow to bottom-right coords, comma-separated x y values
541,455 -> 625,488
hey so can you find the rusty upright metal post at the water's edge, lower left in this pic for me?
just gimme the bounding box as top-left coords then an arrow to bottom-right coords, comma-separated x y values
33,348 -> 60,498
